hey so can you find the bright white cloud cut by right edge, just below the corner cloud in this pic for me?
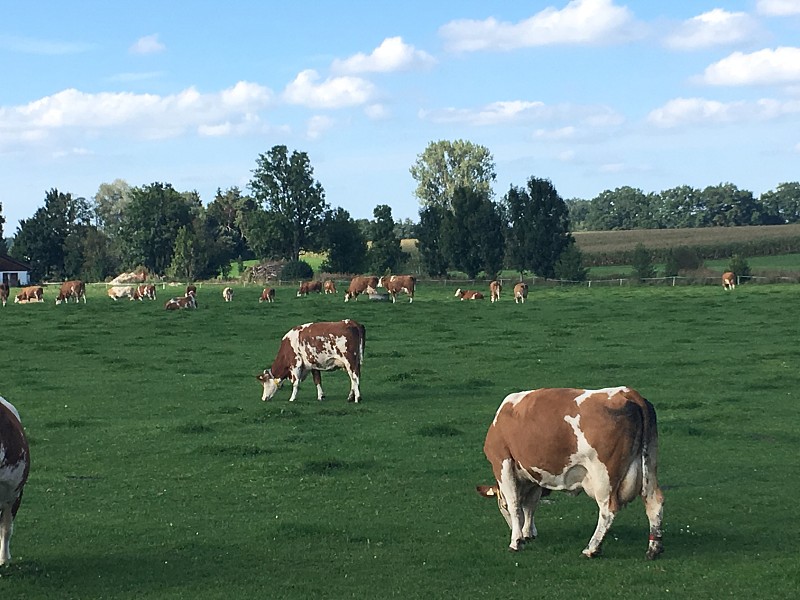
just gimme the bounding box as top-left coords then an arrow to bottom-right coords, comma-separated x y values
701,47 -> 800,85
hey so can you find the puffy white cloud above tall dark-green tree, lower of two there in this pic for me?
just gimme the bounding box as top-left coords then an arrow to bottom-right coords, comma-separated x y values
283,69 -> 375,108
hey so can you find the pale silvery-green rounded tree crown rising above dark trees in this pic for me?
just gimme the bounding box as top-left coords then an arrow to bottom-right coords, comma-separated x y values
410,140 -> 497,210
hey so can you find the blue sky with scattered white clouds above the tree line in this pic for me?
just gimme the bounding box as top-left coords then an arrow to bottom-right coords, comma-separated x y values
0,0 -> 800,235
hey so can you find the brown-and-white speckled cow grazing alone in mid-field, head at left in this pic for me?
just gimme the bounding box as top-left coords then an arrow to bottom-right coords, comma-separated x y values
257,319 -> 366,402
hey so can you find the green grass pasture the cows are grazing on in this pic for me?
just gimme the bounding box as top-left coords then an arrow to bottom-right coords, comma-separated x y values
0,285 -> 800,600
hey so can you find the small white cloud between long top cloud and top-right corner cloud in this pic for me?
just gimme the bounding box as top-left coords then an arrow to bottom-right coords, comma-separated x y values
664,8 -> 757,50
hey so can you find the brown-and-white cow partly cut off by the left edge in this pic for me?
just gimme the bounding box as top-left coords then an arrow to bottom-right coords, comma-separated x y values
0,397 -> 31,566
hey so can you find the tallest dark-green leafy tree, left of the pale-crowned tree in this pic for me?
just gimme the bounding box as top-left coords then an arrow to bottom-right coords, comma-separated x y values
250,146 -> 329,260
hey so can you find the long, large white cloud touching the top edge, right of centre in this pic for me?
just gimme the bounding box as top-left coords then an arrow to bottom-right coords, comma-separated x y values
439,0 -> 633,52
